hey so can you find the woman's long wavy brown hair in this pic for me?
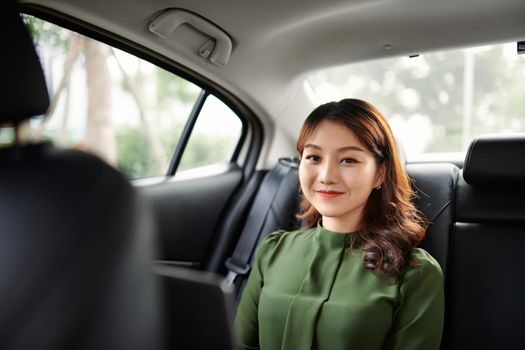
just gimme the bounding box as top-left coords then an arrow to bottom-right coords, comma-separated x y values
297,99 -> 426,281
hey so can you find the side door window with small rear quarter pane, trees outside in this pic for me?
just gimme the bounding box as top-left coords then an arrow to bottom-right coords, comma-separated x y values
24,16 -> 242,178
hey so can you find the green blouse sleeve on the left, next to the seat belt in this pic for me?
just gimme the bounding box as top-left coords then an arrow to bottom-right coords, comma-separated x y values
233,232 -> 281,349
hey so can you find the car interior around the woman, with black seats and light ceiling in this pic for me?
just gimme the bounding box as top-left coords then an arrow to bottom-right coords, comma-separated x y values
0,0 -> 525,350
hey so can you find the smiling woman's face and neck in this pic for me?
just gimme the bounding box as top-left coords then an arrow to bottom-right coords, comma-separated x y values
299,120 -> 384,232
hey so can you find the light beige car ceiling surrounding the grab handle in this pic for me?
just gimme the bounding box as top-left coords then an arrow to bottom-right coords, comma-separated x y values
18,0 -> 525,162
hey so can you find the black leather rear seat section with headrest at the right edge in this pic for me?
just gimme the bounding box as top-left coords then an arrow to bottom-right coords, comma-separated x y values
443,134 -> 525,349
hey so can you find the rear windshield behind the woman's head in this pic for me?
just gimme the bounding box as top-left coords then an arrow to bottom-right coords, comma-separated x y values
307,43 -> 525,160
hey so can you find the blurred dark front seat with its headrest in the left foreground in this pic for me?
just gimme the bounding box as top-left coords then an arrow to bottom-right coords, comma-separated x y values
0,1 -> 164,350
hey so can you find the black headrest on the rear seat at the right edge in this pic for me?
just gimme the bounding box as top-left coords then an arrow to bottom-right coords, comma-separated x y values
463,133 -> 525,187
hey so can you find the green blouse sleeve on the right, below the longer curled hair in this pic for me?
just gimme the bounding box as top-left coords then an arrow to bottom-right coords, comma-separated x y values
385,249 -> 444,350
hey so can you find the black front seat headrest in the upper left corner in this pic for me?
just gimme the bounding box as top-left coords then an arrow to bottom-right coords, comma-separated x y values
0,0 -> 49,124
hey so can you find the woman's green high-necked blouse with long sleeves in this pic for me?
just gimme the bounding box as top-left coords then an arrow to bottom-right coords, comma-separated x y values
234,226 -> 444,350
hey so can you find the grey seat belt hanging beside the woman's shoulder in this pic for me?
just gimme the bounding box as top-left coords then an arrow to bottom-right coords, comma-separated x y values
225,158 -> 299,285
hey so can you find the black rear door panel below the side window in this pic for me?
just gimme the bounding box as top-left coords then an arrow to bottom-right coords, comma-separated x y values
141,166 -> 243,267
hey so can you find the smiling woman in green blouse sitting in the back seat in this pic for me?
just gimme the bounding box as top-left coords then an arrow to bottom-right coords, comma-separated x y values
235,99 -> 444,350
